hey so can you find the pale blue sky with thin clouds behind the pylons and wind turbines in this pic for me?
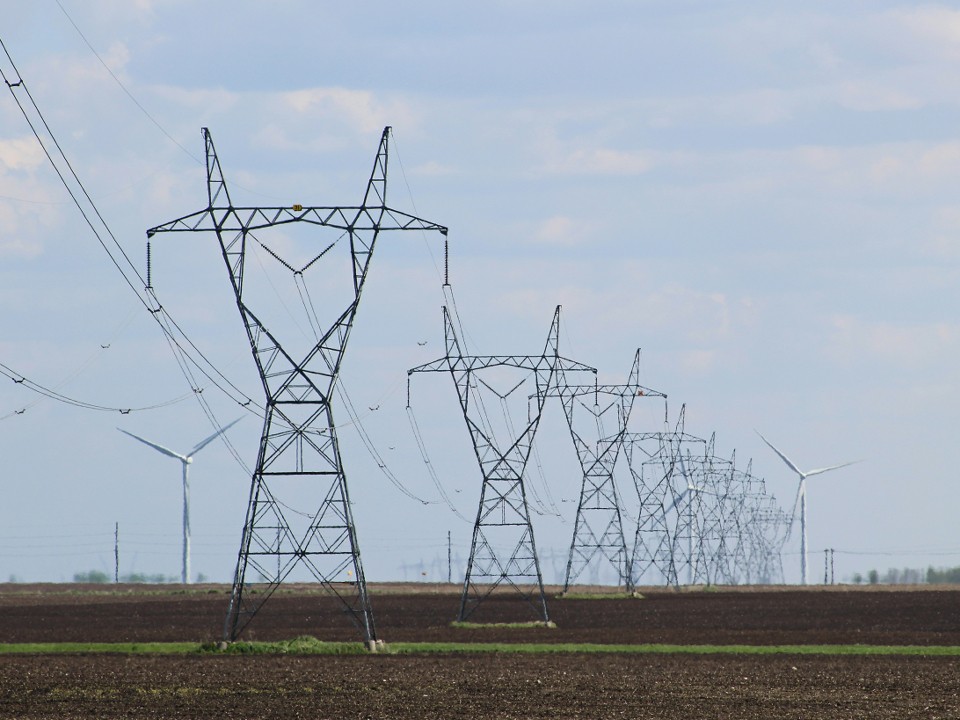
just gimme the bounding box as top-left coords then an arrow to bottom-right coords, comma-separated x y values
0,0 -> 960,582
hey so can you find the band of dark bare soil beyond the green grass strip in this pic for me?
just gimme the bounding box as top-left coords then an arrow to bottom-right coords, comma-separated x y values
0,585 -> 960,645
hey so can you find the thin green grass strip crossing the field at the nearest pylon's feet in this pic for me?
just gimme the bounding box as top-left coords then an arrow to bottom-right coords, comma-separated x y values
0,637 -> 960,657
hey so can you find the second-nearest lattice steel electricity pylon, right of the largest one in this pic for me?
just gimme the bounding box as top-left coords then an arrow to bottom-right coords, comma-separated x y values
408,306 -> 597,622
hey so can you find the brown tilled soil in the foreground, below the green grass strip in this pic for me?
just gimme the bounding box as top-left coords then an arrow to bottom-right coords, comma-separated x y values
0,654 -> 960,720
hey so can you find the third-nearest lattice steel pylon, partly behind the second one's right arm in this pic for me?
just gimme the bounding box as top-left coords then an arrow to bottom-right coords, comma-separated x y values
549,350 -> 667,592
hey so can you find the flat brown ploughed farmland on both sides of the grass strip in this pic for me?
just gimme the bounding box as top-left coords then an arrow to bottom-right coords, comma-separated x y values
0,585 -> 960,718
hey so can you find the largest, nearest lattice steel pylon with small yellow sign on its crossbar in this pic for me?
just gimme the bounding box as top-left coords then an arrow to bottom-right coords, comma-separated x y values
147,127 -> 447,644
